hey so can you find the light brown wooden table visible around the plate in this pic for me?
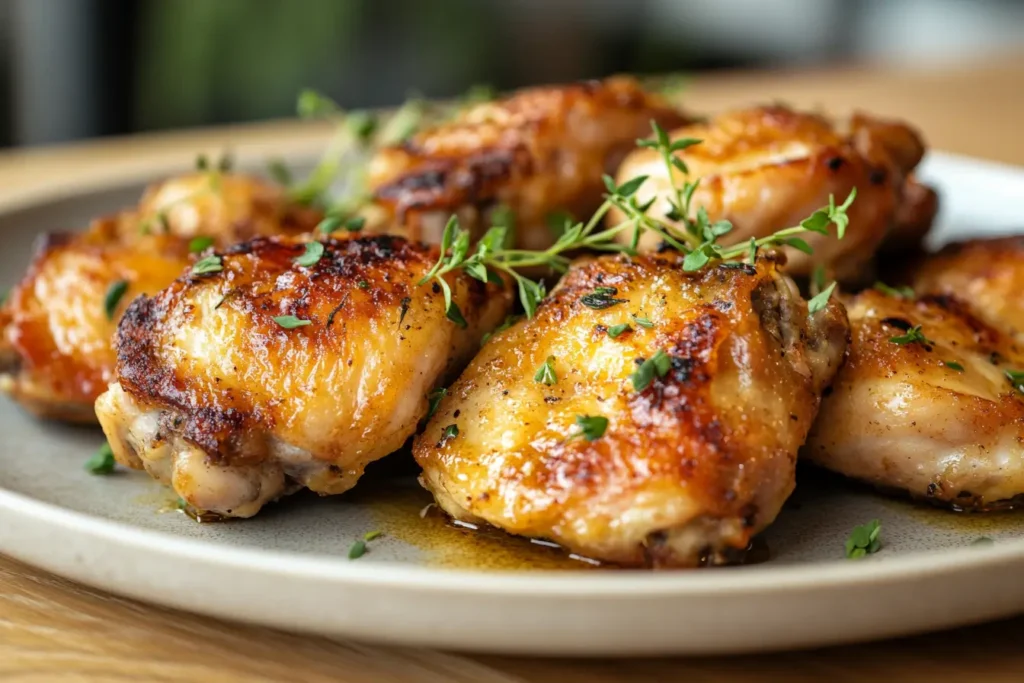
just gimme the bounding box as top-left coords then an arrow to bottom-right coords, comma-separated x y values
0,54 -> 1024,683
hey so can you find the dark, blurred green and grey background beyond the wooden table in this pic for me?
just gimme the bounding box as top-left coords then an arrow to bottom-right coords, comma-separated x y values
0,0 -> 1024,146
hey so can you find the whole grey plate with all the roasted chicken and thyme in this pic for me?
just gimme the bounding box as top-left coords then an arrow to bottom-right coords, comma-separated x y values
0,77 -> 1024,655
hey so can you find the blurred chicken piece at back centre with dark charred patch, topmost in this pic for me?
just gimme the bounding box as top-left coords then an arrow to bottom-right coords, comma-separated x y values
369,77 -> 685,249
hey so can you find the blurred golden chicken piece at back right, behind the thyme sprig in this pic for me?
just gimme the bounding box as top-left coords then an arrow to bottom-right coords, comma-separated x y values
609,105 -> 934,278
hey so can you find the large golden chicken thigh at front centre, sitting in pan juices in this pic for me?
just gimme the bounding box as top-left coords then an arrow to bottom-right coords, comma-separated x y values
414,255 -> 848,566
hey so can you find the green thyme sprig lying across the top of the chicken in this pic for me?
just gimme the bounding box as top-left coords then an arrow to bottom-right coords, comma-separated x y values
420,121 -> 857,326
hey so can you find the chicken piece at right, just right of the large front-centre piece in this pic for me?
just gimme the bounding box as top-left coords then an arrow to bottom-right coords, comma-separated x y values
801,290 -> 1024,510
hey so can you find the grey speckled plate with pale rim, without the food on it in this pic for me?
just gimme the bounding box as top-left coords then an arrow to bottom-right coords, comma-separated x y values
0,154 -> 1024,655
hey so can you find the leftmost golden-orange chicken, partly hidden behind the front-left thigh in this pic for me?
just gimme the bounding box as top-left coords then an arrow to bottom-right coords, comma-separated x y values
0,173 -> 321,423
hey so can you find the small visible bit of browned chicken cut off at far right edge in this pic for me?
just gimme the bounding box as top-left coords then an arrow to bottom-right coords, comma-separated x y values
912,236 -> 1024,343
